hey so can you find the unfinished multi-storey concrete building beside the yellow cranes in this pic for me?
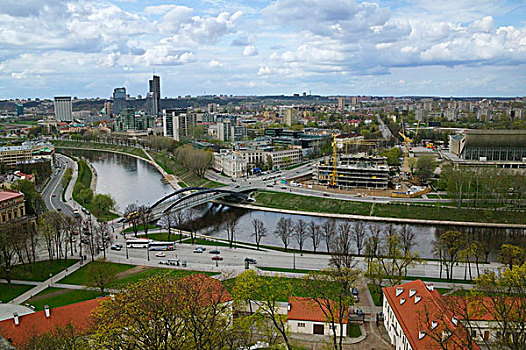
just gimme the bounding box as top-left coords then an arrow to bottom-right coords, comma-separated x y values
314,154 -> 389,190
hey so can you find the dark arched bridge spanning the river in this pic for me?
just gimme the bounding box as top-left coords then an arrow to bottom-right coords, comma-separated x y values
150,187 -> 252,221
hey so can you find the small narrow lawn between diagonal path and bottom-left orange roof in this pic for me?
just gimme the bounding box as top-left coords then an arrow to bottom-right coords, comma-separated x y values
27,288 -> 108,311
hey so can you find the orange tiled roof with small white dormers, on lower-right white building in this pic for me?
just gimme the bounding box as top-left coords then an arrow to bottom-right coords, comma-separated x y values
382,280 -> 479,350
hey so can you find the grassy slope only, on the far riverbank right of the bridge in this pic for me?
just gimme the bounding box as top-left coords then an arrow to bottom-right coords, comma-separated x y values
253,191 -> 526,224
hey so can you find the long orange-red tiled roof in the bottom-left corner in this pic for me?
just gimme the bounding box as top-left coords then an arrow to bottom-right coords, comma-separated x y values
0,299 -> 100,346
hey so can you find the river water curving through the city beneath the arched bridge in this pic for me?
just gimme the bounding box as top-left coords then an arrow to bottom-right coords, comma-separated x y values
63,150 -> 525,259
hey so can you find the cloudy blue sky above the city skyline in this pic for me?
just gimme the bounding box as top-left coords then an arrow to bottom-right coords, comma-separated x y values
0,0 -> 526,99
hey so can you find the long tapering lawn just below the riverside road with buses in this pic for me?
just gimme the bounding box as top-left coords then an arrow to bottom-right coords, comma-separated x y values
59,261 -> 217,288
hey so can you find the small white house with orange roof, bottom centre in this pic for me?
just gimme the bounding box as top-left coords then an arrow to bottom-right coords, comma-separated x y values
287,297 -> 348,336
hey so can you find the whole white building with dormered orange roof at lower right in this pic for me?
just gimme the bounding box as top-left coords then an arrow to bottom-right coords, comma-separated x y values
382,280 -> 479,350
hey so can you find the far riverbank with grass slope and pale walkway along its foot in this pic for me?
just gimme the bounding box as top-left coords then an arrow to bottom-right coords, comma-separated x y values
223,191 -> 526,229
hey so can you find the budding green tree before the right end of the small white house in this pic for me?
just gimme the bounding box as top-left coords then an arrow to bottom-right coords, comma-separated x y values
304,268 -> 360,350
